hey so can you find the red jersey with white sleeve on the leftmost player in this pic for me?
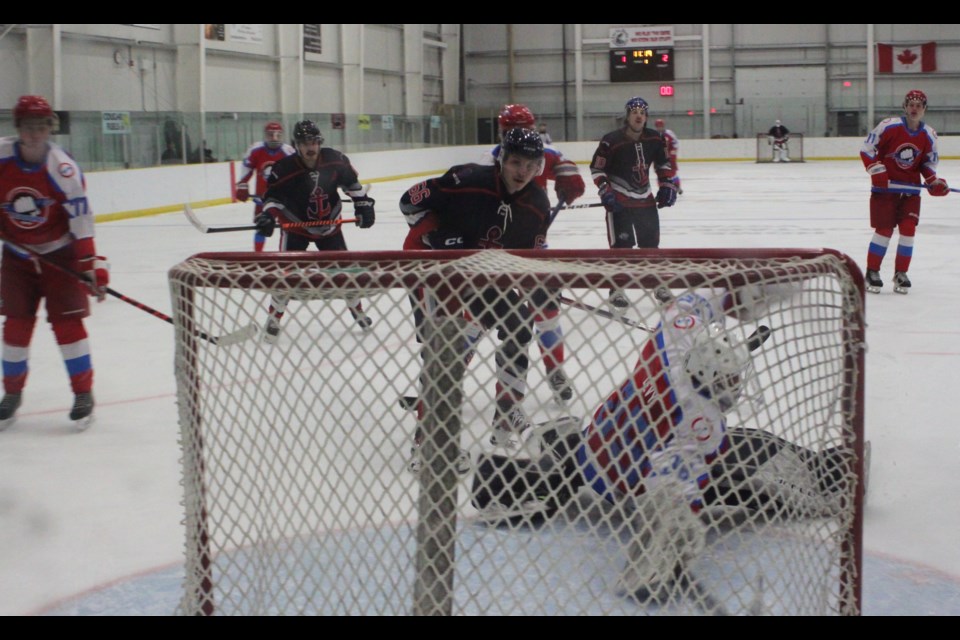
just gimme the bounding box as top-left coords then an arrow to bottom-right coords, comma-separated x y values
0,137 -> 94,254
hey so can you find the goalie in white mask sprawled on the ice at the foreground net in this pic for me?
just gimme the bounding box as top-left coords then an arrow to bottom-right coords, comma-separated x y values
472,285 -> 868,601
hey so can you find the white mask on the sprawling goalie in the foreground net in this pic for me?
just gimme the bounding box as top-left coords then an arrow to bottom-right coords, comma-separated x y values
683,323 -> 753,413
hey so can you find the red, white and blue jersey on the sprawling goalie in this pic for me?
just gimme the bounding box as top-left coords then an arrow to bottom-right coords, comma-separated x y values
577,292 -> 729,511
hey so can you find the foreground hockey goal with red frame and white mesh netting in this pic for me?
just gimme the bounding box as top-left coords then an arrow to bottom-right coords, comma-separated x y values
169,249 -> 865,615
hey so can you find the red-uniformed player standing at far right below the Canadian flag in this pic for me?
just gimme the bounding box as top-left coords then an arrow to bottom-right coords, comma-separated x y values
860,90 -> 950,293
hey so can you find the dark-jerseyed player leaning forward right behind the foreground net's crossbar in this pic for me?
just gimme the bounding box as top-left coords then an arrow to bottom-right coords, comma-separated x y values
400,128 -> 550,470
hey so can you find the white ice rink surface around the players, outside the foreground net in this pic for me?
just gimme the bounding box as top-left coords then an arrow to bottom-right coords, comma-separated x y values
0,159 -> 960,615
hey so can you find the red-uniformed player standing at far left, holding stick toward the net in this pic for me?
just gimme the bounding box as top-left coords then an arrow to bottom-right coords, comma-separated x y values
0,95 -> 109,429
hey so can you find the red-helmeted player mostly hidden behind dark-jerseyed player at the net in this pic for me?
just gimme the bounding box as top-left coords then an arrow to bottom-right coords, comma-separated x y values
485,104 -> 586,403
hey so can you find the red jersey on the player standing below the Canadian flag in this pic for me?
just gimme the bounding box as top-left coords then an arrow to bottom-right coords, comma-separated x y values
860,116 -> 940,194
